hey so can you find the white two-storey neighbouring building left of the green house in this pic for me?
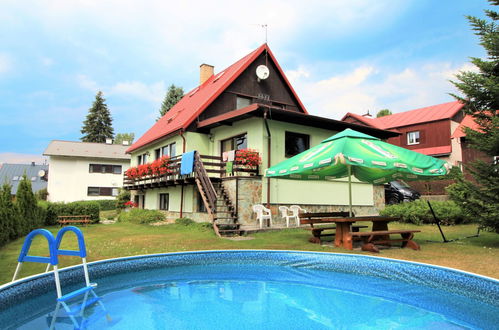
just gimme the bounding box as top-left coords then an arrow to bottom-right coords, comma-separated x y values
43,140 -> 130,202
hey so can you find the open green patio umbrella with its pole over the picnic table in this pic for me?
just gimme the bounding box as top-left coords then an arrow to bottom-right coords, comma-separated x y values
265,128 -> 450,215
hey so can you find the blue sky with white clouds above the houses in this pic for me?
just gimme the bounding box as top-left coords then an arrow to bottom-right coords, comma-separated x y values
0,0 -> 489,163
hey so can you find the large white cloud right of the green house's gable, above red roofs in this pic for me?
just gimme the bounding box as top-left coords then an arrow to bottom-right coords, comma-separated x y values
287,63 -> 473,119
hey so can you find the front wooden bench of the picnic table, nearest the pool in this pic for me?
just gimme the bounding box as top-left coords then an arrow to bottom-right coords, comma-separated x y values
349,230 -> 421,252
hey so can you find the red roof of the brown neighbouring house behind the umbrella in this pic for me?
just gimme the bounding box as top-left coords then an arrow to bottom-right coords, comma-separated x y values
372,101 -> 463,129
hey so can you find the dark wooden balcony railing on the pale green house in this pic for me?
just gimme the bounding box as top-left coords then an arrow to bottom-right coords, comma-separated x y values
123,155 -> 259,189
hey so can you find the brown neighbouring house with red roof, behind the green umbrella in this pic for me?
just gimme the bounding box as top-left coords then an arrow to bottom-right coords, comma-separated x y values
342,101 -> 464,166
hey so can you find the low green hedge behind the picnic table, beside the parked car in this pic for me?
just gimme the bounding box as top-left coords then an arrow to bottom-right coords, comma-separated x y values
380,200 -> 472,225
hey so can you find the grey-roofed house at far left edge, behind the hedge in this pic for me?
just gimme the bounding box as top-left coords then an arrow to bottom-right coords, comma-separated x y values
0,162 -> 48,195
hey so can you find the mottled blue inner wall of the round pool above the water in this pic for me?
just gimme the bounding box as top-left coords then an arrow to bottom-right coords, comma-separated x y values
0,250 -> 499,328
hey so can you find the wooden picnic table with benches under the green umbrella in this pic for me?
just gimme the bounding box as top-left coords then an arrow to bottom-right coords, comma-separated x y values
300,212 -> 420,252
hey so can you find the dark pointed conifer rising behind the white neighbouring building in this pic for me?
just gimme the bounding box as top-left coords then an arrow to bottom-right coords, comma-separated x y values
80,91 -> 114,143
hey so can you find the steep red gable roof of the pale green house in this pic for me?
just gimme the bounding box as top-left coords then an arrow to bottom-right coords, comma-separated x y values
126,44 -> 308,153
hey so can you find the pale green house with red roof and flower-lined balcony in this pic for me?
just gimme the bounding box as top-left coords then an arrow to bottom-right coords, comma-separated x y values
124,44 -> 399,232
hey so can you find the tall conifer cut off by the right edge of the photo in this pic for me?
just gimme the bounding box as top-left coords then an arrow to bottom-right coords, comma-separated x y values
448,0 -> 499,233
